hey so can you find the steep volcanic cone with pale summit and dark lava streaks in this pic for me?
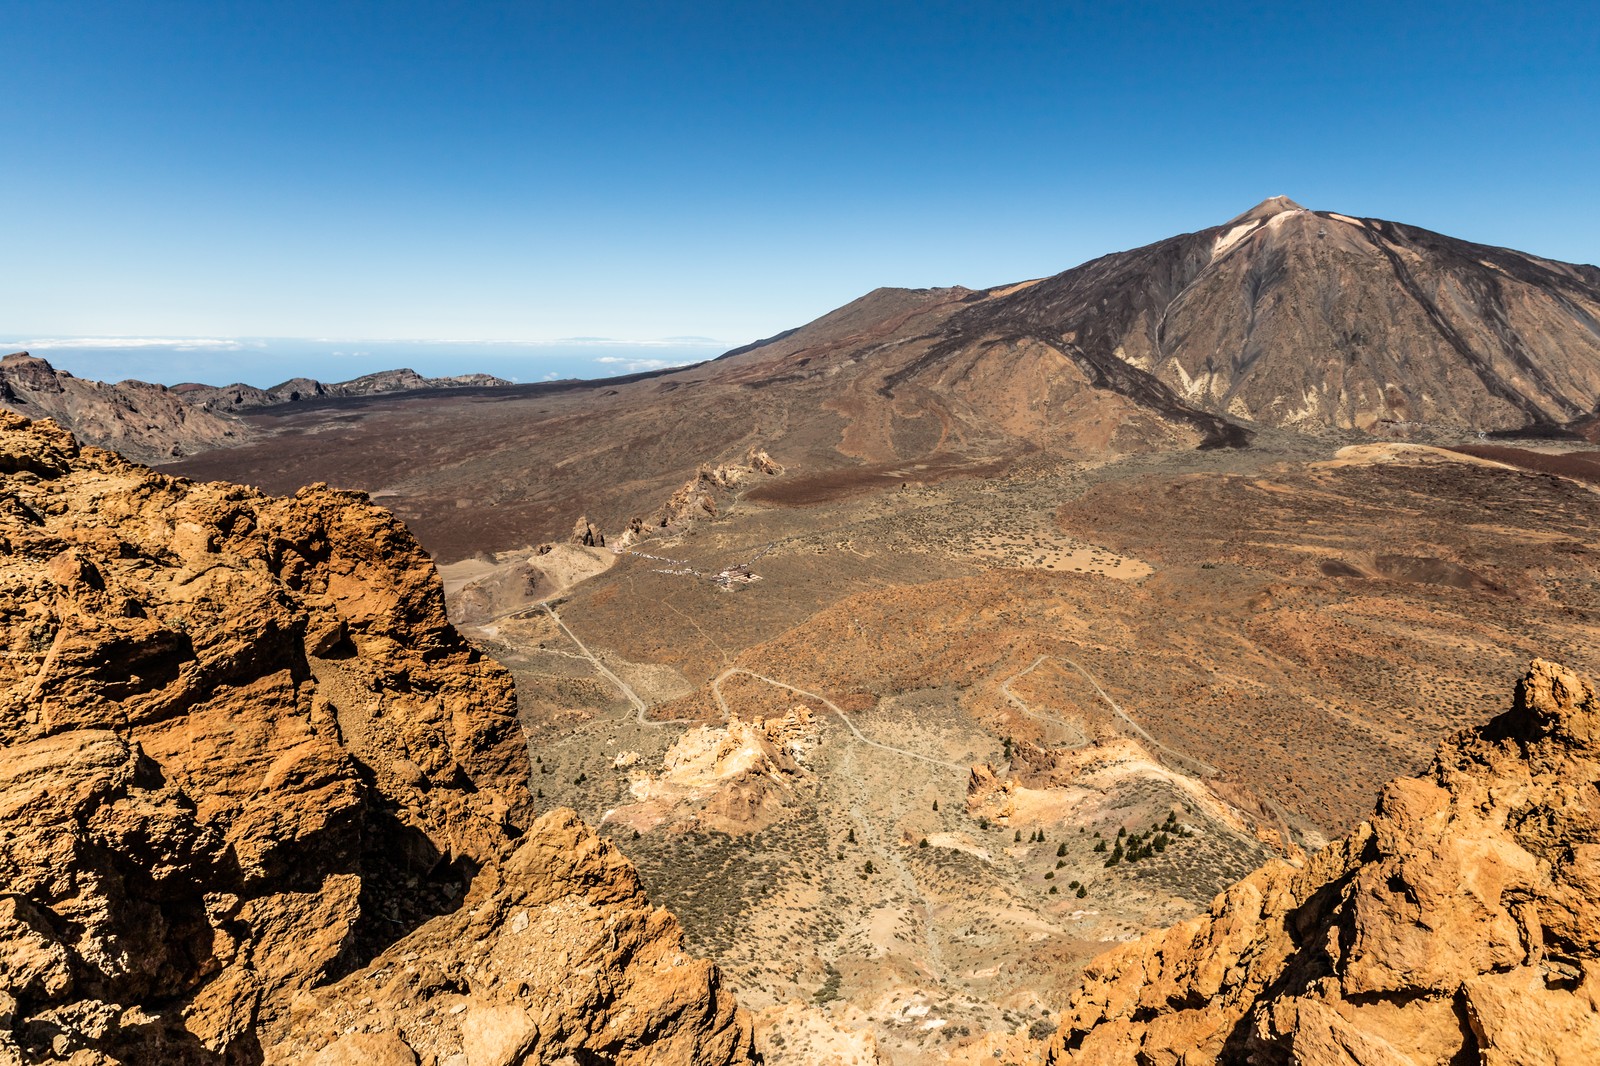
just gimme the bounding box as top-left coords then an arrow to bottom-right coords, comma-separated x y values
960,197 -> 1600,429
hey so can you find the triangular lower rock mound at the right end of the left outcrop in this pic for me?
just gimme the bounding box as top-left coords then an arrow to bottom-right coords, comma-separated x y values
267,810 -> 750,1066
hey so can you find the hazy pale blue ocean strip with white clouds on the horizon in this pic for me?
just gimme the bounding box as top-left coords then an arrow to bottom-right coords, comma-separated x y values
0,338 -> 726,387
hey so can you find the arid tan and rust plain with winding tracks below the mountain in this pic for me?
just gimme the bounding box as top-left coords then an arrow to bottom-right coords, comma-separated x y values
172,412 -> 1600,1063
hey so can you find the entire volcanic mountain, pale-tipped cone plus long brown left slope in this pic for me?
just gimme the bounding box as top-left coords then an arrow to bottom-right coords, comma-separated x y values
168,197 -> 1600,559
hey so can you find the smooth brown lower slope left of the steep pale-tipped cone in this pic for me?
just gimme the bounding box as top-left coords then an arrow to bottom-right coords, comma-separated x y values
159,278 -> 1209,560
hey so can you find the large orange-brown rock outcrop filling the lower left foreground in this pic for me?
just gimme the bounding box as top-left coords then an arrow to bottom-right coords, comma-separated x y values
0,413 -> 750,1066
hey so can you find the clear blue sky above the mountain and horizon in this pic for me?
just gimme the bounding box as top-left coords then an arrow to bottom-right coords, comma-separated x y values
0,0 -> 1600,381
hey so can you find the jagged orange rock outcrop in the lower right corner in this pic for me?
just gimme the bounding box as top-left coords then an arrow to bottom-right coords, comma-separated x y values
1046,659 -> 1600,1066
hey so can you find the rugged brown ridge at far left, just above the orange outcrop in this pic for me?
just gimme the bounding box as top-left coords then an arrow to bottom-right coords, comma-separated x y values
0,352 -> 243,463
